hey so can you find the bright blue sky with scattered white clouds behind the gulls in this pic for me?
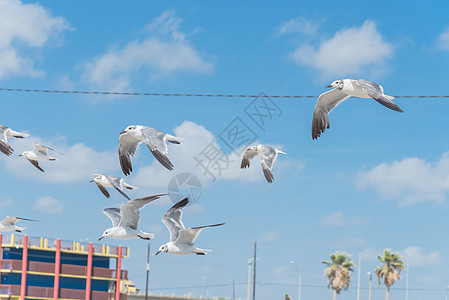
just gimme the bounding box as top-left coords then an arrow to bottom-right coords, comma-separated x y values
0,0 -> 449,300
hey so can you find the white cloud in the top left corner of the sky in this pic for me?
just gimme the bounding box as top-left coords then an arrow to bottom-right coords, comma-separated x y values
0,0 -> 69,78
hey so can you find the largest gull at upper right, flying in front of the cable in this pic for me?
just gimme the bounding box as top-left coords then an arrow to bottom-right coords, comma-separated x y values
312,79 -> 404,139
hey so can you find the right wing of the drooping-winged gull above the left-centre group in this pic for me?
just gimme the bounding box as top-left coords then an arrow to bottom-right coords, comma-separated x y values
142,126 -> 174,171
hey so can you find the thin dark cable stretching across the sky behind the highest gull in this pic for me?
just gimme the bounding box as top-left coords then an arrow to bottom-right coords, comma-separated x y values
0,88 -> 449,99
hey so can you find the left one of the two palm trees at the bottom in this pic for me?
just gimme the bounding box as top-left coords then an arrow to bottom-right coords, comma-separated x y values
323,252 -> 354,300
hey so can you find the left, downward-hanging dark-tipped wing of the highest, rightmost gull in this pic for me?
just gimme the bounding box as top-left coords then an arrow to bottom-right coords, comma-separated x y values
312,89 -> 350,139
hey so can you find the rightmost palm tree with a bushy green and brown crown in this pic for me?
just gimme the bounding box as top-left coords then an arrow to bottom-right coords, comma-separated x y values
375,249 -> 404,300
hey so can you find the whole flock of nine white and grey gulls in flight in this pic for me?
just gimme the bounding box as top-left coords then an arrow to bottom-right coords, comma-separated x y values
0,79 -> 403,255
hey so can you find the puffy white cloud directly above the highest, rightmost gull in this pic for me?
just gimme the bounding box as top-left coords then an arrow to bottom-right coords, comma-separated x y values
290,21 -> 393,79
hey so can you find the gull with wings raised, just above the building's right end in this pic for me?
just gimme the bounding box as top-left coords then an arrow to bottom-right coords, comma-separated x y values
98,194 -> 167,240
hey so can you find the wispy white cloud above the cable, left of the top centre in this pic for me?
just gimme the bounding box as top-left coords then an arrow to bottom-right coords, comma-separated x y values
84,11 -> 213,91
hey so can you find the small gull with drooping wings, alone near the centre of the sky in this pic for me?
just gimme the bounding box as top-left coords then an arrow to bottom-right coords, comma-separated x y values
240,145 -> 287,183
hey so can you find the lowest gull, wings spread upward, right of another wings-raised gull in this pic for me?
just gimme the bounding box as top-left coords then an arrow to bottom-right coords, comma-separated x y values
156,198 -> 225,255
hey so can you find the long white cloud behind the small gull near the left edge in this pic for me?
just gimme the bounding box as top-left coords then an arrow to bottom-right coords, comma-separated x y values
3,136 -> 119,182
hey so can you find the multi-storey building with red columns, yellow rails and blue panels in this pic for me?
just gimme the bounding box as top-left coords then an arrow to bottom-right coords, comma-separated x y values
0,234 -> 129,300
